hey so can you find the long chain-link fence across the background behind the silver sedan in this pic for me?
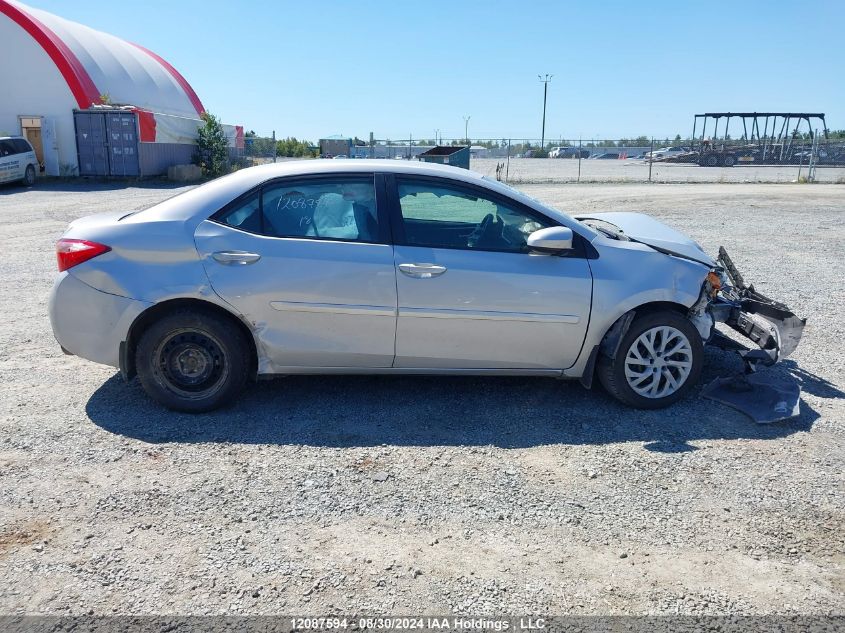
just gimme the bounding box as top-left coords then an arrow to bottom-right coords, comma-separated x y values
230,134 -> 845,184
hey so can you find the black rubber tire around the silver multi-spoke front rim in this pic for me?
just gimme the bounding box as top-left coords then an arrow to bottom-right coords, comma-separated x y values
596,311 -> 704,409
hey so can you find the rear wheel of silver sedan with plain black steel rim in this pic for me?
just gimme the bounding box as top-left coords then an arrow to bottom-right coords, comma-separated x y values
135,309 -> 250,413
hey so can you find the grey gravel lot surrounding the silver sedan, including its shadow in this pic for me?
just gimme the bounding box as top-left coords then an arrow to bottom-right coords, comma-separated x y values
0,178 -> 845,614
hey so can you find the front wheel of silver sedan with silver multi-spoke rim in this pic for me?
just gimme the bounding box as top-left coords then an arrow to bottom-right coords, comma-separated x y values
597,311 -> 704,409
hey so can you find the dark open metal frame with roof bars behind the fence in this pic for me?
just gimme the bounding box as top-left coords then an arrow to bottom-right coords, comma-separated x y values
692,112 -> 828,167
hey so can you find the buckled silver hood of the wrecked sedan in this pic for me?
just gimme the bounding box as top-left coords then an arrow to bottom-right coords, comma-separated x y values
574,211 -> 716,267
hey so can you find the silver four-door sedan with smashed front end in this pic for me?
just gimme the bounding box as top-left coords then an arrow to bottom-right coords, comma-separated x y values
50,160 -> 803,412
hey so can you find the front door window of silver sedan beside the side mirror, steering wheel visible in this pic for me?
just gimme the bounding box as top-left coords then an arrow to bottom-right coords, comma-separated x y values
399,179 -> 553,253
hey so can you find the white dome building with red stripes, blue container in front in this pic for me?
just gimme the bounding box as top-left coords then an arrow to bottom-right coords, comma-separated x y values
0,0 -> 237,176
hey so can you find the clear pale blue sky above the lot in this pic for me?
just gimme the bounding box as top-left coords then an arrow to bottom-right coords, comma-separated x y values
27,0 -> 845,141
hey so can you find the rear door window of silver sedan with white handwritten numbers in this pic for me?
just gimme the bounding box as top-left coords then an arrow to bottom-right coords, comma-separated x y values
214,177 -> 379,242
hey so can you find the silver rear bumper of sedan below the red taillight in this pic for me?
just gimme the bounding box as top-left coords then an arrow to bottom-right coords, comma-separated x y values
50,272 -> 152,367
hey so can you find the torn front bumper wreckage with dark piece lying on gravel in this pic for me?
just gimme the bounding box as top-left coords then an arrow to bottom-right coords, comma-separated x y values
702,247 -> 807,424
